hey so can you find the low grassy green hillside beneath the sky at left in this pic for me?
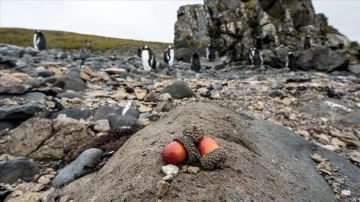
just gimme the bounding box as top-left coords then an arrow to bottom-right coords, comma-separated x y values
0,28 -> 169,53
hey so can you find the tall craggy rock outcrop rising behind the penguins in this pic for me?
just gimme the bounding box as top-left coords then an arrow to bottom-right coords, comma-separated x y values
174,0 -> 350,65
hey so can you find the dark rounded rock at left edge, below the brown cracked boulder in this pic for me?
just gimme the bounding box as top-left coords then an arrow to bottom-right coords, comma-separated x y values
0,157 -> 40,184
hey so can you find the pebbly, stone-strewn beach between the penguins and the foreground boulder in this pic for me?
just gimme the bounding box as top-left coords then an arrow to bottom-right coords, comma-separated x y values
0,44 -> 360,201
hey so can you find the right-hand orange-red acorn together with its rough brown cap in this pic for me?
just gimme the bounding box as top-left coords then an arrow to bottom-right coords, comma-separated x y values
197,137 -> 227,170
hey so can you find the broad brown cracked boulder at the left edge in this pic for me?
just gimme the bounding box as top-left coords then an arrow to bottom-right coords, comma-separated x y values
0,114 -> 96,160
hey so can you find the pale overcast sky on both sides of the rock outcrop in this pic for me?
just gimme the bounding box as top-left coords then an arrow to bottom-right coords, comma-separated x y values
0,0 -> 360,42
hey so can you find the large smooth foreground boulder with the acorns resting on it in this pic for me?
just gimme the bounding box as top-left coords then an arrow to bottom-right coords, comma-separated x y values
57,103 -> 360,201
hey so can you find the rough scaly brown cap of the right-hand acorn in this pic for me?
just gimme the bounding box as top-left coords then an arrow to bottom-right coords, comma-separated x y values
200,147 -> 227,170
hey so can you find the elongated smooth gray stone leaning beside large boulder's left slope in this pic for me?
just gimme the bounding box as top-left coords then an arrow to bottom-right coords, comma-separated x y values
51,148 -> 104,186
